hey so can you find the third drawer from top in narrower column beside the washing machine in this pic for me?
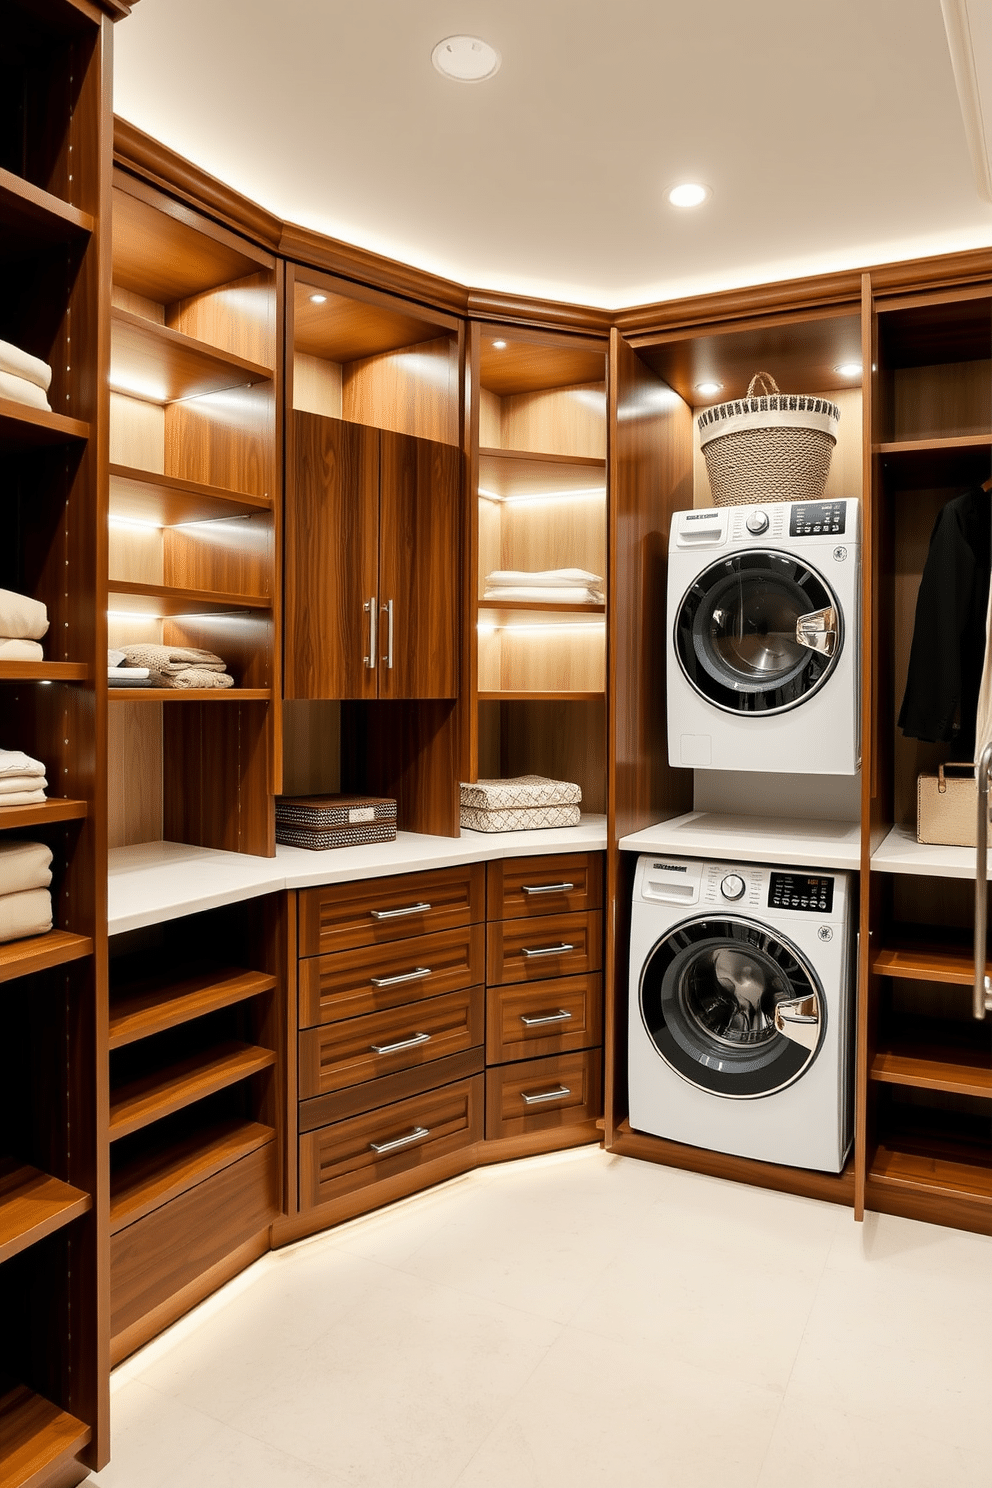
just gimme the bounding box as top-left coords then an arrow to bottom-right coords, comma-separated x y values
486,972 -> 602,1064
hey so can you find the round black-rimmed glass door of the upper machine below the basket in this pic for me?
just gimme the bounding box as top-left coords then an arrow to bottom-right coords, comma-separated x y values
675,551 -> 843,713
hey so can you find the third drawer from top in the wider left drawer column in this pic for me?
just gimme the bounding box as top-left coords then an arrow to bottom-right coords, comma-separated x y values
299,987 -> 485,1100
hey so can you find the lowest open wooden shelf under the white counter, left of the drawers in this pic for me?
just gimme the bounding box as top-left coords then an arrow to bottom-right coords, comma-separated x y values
110,1120 -> 275,1235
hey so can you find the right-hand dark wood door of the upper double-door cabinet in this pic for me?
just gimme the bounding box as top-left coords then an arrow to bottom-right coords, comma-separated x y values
379,432 -> 461,698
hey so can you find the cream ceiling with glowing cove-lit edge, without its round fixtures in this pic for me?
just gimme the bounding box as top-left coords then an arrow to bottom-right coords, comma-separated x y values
115,0 -> 992,308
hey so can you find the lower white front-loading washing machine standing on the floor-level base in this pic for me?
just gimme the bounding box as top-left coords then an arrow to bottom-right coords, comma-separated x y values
628,856 -> 854,1173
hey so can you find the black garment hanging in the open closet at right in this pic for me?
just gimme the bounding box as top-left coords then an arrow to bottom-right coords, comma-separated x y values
898,487 -> 992,759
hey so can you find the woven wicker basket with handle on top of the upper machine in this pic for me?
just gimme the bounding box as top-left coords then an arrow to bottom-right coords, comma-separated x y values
696,372 -> 840,506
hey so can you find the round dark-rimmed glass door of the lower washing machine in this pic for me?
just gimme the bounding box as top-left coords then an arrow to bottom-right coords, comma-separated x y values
640,917 -> 825,1100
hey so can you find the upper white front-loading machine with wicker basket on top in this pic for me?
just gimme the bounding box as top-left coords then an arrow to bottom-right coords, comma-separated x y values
668,500 -> 861,775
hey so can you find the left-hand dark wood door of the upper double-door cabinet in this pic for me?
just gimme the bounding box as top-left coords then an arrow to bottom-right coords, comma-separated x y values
286,412 -> 379,698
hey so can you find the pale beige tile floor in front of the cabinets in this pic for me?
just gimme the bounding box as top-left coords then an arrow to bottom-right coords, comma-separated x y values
89,1147 -> 992,1488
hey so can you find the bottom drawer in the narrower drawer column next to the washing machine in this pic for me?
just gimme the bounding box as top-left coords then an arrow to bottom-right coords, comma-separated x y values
486,1049 -> 602,1141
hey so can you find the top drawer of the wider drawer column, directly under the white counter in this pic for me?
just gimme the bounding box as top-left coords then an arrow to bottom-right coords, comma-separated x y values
299,863 -> 485,955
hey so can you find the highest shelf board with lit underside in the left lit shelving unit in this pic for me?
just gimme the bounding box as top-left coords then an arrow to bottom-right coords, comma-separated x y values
110,310 -> 274,403
